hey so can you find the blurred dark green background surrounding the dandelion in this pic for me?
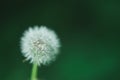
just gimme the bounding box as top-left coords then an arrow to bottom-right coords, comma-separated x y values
0,0 -> 120,80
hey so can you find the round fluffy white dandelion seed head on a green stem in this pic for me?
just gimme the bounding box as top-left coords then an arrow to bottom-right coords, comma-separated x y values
21,26 -> 60,65
